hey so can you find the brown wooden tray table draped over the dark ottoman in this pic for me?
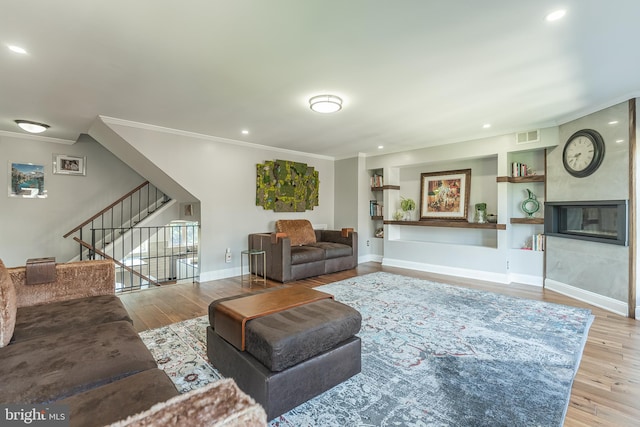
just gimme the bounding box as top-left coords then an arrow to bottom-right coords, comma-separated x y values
214,286 -> 333,351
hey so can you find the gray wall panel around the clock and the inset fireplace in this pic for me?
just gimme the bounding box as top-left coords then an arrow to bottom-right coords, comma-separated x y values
546,102 -> 629,302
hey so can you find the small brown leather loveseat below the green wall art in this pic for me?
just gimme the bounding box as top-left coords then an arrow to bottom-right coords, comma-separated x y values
249,219 -> 358,283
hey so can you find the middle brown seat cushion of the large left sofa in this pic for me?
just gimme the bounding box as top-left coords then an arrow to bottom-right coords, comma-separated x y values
0,321 -> 157,403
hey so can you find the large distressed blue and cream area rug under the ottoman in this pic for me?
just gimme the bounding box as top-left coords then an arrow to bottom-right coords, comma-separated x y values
140,272 -> 593,427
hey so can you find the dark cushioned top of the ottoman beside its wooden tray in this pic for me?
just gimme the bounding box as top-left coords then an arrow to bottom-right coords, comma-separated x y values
245,299 -> 362,372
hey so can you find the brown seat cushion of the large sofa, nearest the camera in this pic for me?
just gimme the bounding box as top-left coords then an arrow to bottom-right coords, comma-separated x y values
56,369 -> 179,427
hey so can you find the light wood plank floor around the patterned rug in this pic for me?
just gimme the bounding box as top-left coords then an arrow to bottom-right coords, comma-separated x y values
121,263 -> 640,426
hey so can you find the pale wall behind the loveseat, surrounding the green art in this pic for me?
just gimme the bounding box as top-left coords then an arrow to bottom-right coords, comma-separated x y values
93,119 -> 334,281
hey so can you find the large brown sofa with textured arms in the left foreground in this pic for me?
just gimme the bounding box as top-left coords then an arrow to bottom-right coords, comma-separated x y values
0,260 -> 266,427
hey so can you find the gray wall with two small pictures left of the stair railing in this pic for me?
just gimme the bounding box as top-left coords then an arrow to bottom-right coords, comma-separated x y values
0,133 -> 144,267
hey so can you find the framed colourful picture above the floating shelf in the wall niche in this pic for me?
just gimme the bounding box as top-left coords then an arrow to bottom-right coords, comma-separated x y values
420,169 -> 471,221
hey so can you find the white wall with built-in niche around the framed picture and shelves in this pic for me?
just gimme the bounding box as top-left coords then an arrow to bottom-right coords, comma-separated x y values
361,128 -> 558,284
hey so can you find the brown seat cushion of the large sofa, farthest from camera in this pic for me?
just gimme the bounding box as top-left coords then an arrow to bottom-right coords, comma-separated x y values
12,295 -> 133,343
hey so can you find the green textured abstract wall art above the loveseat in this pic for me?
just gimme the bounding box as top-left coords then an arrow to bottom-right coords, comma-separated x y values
256,160 -> 320,212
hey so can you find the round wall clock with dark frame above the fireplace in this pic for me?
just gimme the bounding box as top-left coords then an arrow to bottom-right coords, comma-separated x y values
562,129 -> 604,178
